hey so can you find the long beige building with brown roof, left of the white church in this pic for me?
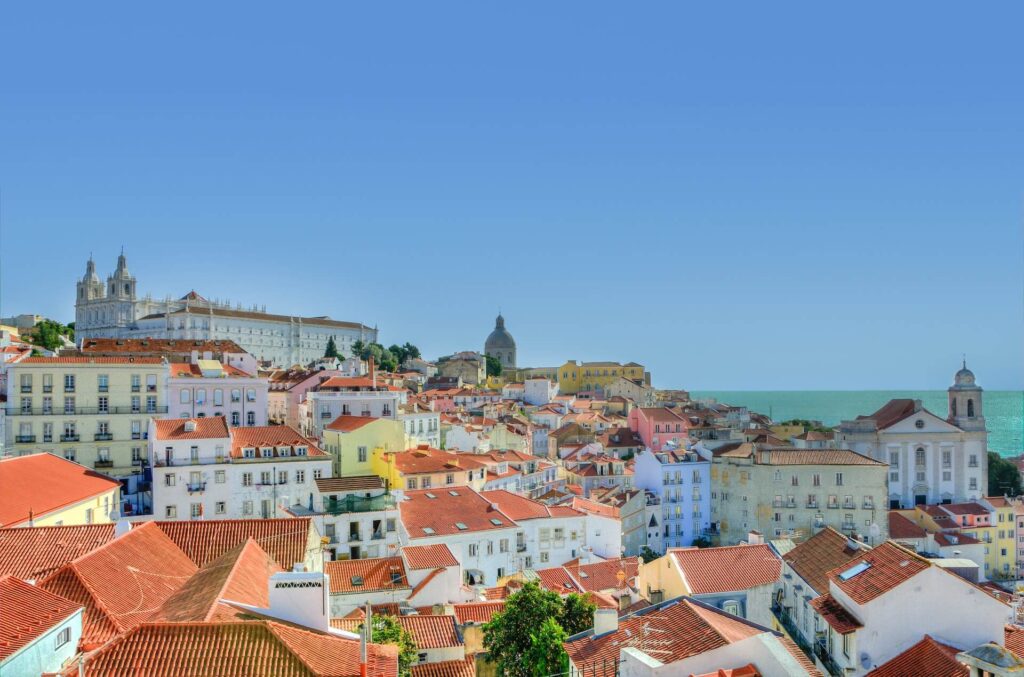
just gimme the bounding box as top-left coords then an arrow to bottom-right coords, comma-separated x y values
711,442 -> 889,545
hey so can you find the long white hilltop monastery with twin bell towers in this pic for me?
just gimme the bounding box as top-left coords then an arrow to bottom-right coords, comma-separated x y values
75,252 -> 377,367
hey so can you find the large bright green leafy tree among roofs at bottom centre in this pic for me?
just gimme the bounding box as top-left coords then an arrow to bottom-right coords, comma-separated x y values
483,581 -> 564,677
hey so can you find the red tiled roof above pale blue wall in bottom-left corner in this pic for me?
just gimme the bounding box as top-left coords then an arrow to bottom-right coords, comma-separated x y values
0,576 -> 82,663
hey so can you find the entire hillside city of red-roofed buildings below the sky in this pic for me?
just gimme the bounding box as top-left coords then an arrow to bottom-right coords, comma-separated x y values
0,251 -> 1024,677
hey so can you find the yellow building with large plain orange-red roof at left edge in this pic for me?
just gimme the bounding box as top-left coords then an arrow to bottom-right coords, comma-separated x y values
0,454 -> 121,527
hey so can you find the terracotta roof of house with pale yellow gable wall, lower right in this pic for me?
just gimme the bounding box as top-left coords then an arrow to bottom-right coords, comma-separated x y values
669,544 -> 782,595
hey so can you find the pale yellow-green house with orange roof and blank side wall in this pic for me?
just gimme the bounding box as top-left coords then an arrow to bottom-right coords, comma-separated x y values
324,416 -> 409,479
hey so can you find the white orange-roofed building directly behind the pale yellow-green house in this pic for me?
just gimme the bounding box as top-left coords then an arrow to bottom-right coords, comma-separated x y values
304,374 -> 409,439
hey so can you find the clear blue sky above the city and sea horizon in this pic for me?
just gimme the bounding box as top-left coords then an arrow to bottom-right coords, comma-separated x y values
0,1 -> 1024,389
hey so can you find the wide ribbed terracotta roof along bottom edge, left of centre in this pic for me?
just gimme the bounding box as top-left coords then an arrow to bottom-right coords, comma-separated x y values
72,621 -> 397,677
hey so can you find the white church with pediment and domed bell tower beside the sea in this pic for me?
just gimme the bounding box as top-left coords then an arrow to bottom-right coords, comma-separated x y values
836,364 -> 988,509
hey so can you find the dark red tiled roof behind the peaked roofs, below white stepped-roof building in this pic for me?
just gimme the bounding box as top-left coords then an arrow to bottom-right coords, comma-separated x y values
156,517 -> 312,570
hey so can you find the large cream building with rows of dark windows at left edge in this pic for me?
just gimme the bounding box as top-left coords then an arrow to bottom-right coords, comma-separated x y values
6,357 -> 167,508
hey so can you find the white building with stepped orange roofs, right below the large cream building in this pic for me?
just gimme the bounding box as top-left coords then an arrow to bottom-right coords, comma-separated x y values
148,416 -> 331,519
